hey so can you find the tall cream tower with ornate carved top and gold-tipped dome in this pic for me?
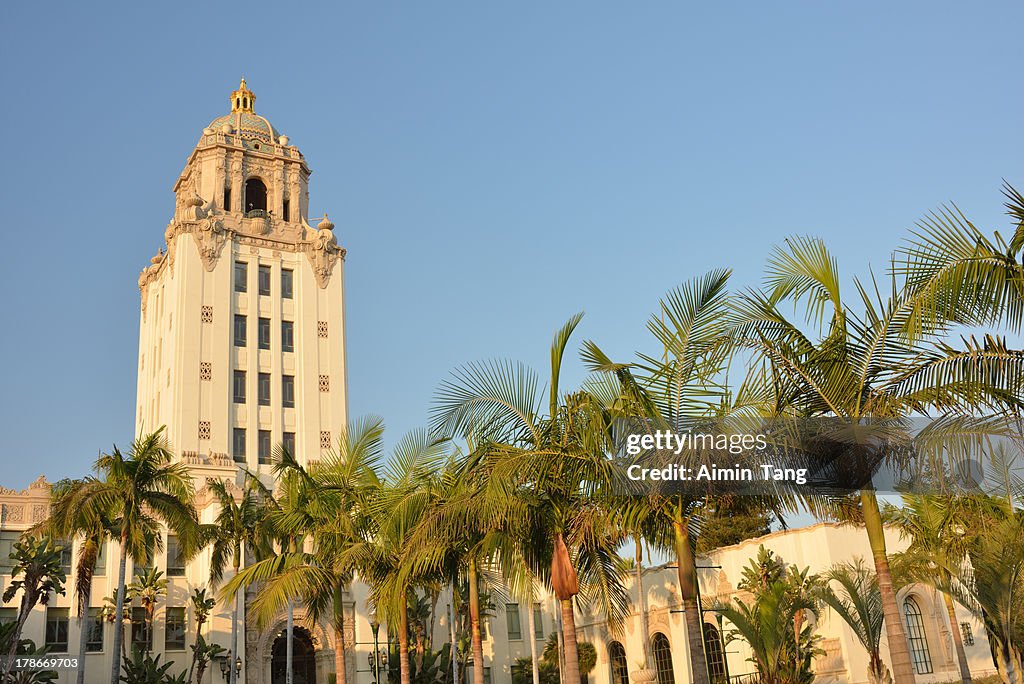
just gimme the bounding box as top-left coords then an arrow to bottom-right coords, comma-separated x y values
136,79 -> 347,474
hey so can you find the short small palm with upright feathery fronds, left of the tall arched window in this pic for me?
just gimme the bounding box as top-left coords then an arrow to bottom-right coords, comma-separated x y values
821,557 -> 892,684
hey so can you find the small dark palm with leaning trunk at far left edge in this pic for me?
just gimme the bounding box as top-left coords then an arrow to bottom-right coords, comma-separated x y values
0,537 -> 67,681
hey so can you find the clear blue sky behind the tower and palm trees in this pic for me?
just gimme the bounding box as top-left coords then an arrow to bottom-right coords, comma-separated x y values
0,0 -> 1024,487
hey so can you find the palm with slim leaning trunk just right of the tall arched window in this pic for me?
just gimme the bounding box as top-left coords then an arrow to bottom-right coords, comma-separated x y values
884,494 -> 971,684
